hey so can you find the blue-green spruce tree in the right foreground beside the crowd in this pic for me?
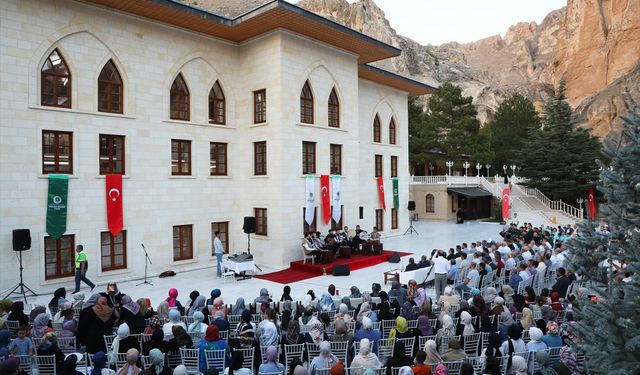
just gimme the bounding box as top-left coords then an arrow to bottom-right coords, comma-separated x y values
569,100 -> 640,375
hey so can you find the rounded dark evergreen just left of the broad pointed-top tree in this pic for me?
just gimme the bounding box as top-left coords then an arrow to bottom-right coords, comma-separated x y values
487,94 -> 540,167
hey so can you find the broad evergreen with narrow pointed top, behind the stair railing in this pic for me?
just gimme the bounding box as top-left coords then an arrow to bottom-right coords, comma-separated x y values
516,81 -> 601,203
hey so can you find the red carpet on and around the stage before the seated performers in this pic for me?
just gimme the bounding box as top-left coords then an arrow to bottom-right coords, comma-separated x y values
255,250 -> 411,284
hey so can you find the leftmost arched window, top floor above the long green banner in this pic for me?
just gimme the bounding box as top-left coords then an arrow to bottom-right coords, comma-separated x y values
40,49 -> 71,108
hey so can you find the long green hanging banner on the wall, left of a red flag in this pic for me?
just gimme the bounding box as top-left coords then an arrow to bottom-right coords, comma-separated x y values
47,174 -> 69,240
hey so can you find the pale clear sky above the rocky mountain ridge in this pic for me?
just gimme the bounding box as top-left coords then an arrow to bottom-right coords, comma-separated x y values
349,0 -> 567,45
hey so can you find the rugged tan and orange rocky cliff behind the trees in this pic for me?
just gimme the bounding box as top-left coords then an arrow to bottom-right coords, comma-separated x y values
298,0 -> 640,137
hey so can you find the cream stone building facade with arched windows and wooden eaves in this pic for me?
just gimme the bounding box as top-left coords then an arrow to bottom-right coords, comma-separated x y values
0,0 -> 431,290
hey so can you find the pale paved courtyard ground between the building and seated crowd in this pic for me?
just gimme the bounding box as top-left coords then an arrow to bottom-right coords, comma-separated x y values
17,221 -> 501,307
